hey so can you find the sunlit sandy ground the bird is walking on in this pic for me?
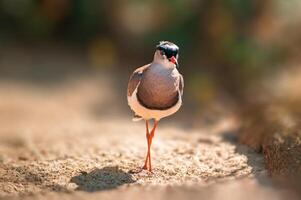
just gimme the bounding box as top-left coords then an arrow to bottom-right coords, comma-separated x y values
0,77 -> 292,199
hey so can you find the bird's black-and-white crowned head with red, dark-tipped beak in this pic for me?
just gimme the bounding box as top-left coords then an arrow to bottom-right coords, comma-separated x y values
154,41 -> 179,67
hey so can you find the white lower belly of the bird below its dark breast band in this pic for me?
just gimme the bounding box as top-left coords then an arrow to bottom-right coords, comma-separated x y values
127,85 -> 182,121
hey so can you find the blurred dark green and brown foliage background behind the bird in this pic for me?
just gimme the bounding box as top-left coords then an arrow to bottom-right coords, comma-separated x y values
0,0 -> 301,118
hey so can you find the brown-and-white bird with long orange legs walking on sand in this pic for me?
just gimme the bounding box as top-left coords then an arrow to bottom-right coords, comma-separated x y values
127,41 -> 184,172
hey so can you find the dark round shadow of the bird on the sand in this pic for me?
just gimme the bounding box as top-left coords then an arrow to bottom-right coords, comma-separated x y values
70,167 -> 135,192
